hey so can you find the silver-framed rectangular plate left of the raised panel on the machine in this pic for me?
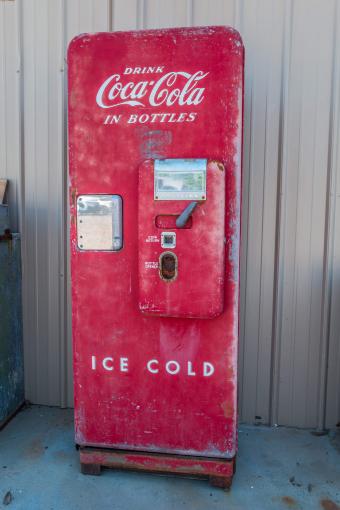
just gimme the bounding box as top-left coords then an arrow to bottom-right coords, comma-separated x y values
77,195 -> 123,251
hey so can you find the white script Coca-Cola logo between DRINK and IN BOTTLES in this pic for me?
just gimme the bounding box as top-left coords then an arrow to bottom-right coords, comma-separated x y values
96,68 -> 209,108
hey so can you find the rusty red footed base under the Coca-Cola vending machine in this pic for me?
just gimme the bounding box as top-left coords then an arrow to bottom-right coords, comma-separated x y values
79,446 -> 235,490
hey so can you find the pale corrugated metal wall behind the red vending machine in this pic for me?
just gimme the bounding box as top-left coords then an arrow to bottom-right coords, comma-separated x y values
0,0 -> 340,428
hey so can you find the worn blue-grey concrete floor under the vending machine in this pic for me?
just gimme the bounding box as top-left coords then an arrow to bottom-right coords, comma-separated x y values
0,406 -> 340,510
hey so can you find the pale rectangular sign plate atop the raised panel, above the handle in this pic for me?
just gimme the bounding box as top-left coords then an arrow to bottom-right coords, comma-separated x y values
154,159 -> 207,200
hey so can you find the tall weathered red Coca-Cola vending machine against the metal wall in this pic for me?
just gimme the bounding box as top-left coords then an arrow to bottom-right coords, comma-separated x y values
68,27 -> 244,487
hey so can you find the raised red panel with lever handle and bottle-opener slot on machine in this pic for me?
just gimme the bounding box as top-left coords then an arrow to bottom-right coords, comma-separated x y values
138,159 -> 225,318
